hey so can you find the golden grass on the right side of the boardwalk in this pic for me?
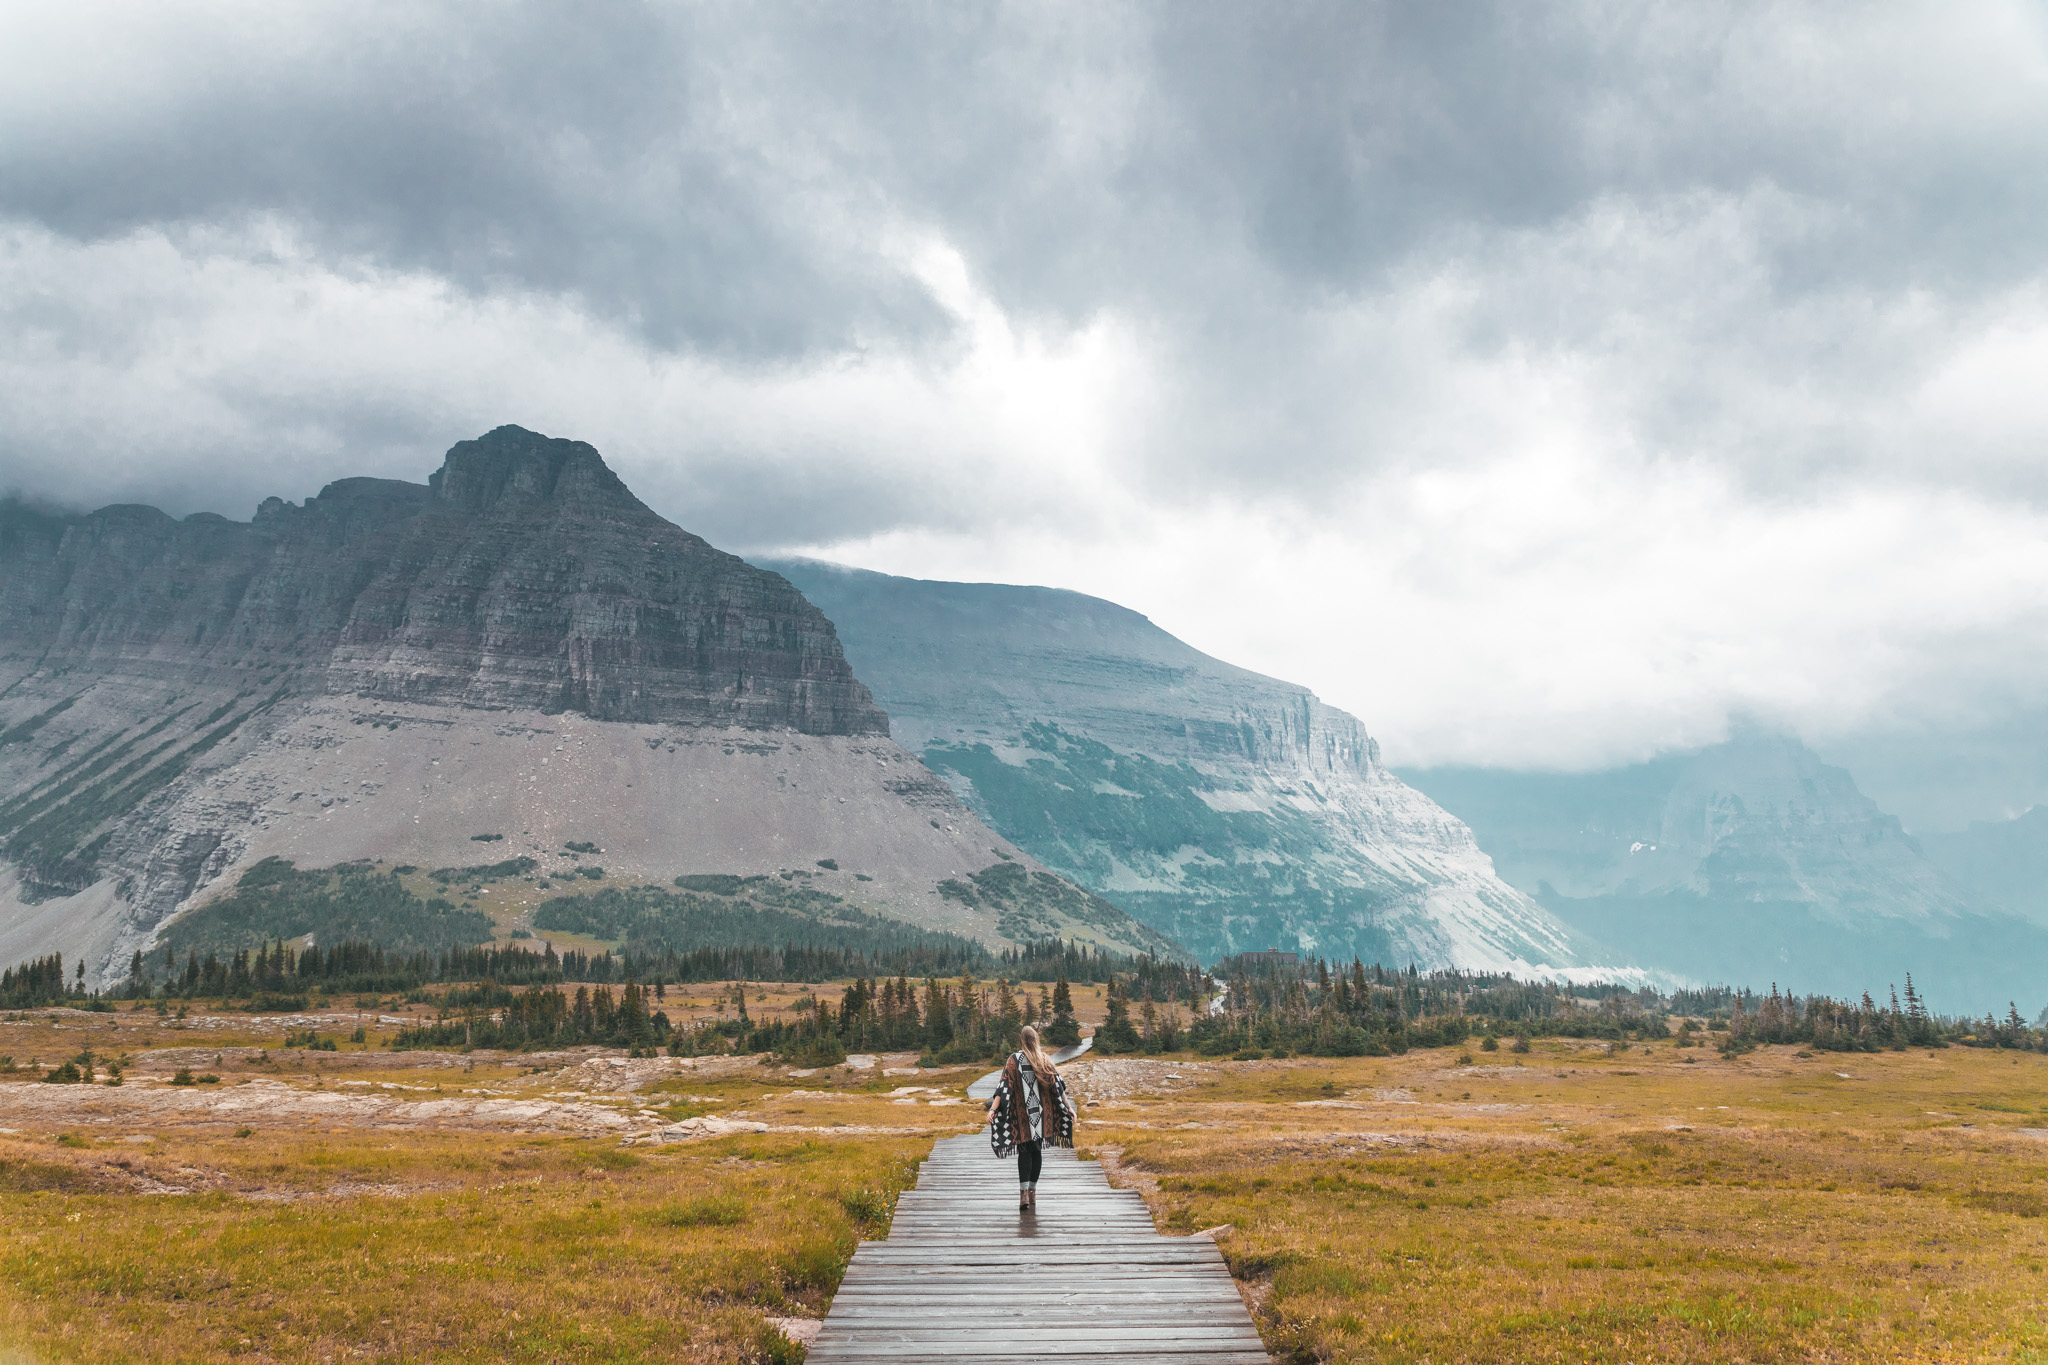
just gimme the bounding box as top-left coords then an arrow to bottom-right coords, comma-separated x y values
1092,1044 -> 2048,1361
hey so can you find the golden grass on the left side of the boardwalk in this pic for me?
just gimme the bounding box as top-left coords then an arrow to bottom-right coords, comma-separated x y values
0,986 -> 991,1361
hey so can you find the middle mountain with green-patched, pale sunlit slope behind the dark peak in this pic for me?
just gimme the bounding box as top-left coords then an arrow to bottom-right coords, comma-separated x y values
770,561 -> 1622,976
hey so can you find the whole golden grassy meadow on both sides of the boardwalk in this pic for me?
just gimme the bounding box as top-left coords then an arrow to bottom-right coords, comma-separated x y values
0,988 -> 2048,1365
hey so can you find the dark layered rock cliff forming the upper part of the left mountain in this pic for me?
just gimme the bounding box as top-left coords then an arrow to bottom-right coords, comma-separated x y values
0,426 -> 889,735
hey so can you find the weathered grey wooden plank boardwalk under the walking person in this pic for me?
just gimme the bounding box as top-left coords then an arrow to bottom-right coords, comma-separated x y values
809,1134 -> 1270,1365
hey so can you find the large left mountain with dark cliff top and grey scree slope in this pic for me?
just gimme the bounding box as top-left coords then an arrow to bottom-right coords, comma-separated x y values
0,426 -> 1176,974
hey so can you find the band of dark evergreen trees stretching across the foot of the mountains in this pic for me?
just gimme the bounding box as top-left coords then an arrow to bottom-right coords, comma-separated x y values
0,939 -> 2048,1064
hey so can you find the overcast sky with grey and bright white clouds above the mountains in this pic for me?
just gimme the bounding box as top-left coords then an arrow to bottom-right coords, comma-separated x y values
0,0 -> 2048,822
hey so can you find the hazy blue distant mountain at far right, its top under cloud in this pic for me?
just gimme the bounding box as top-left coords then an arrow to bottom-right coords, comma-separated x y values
1403,731 -> 2048,1013
